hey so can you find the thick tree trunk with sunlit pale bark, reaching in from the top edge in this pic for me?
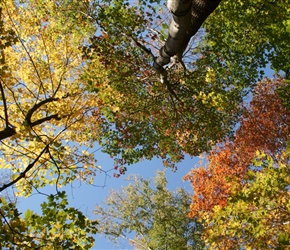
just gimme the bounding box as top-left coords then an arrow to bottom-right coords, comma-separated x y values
154,0 -> 221,71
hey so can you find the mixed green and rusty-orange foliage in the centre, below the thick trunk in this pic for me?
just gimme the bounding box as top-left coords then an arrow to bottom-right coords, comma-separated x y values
84,1 -> 251,172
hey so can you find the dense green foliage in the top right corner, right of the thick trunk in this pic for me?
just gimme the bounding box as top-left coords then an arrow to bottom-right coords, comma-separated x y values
202,0 -> 290,80
